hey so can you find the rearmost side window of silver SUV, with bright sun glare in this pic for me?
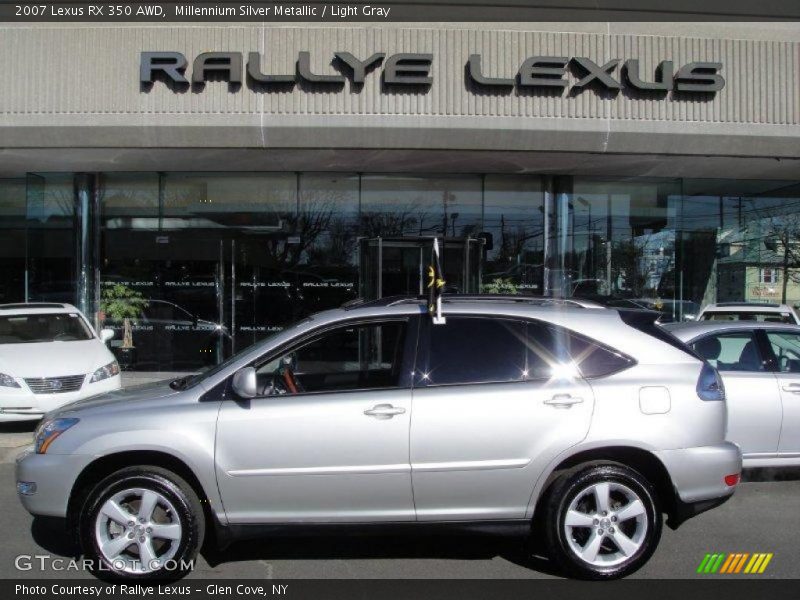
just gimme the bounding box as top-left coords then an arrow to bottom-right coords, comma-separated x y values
528,323 -> 634,379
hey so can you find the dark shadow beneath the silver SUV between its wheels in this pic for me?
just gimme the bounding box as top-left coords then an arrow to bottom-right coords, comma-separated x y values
202,534 -> 558,575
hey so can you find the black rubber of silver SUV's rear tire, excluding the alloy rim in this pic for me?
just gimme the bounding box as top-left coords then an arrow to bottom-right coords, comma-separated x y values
545,464 -> 662,579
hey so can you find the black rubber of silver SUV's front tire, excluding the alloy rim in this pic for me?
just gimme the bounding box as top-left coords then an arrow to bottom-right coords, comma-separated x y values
78,467 -> 205,581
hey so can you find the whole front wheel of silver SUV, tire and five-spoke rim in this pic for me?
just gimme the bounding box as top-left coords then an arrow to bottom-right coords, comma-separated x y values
78,466 -> 205,581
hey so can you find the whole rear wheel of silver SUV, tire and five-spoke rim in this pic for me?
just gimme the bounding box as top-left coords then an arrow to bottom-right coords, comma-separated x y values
543,463 -> 662,580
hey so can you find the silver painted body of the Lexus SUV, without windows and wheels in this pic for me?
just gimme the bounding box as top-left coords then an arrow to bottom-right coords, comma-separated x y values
17,301 -> 741,524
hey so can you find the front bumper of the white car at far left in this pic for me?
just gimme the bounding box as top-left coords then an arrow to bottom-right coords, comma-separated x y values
0,373 -> 122,423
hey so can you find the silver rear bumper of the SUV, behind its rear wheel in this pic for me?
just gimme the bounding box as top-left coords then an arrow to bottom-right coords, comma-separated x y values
654,442 -> 742,520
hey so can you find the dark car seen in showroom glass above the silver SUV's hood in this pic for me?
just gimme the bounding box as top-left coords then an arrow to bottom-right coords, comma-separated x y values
106,298 -> 228,371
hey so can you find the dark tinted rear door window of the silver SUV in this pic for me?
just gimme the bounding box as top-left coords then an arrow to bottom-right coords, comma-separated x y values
423,317 -> 526,385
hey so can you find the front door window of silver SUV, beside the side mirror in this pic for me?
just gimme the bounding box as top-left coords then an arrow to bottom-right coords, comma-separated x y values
258,321 -> 406,394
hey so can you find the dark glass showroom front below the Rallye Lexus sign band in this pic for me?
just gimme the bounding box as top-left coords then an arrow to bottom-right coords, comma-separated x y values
0,173 -> 800,372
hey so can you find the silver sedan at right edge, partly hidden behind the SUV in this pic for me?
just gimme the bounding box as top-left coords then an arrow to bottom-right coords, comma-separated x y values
667,321 -> 800,467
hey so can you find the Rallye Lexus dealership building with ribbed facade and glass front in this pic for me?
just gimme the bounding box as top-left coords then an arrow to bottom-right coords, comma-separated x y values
0,22 -> 800,371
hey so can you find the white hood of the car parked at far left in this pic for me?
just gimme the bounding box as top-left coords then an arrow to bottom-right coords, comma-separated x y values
0,339 -> 114,377
